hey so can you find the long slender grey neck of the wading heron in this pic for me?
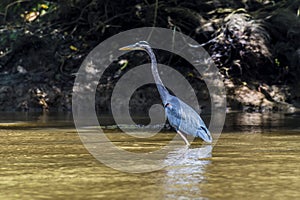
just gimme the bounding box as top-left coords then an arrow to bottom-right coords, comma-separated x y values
146,48 -> 169,104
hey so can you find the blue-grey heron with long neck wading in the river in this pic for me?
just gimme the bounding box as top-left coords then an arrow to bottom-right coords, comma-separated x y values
120,41 -> 212,146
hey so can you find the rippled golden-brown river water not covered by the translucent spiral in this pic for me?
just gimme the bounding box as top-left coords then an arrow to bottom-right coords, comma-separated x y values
0,115 -> 300,199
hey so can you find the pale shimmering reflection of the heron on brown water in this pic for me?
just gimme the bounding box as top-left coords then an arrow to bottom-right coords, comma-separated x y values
164,145 -> 212,199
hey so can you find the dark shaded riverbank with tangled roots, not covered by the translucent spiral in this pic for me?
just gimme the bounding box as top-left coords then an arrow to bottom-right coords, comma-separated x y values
0,0 -> 300,113
